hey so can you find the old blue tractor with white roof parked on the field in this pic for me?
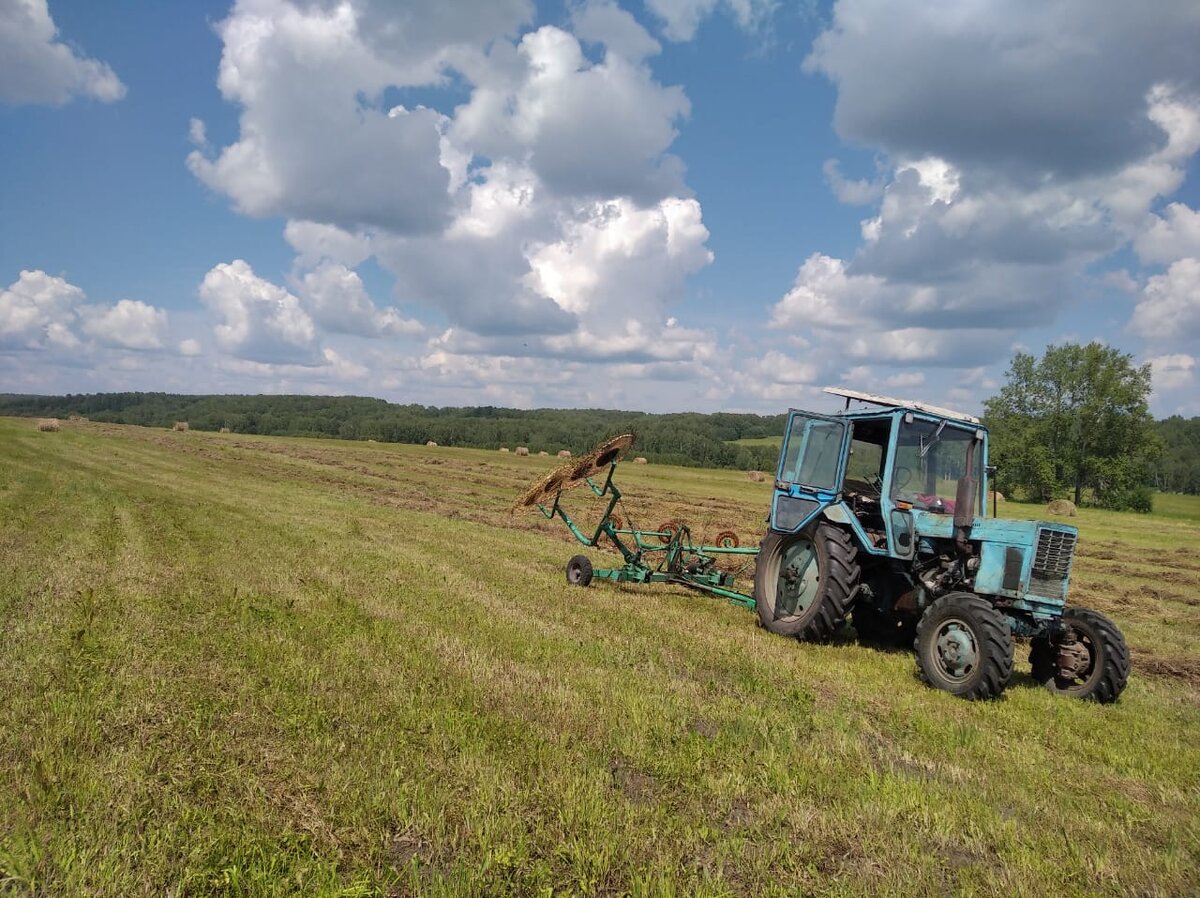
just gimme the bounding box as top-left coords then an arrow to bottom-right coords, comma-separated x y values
754,388 -> 1129,702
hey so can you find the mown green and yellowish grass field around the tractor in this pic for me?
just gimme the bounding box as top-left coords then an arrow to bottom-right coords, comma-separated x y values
0,419 -> 1200,896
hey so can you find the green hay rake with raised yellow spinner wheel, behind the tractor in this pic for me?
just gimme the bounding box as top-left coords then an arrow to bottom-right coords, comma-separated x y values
512,433 -> 758,609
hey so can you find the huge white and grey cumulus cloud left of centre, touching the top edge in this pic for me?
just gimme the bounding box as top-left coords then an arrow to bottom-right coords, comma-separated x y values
190,0 -> 712,358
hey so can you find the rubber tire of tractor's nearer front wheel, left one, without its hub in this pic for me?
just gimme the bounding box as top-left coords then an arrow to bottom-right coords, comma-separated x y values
913,592 -> 1013,700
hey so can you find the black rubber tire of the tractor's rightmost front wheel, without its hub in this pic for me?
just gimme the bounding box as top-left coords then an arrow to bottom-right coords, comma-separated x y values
1030,607 -> 1129,705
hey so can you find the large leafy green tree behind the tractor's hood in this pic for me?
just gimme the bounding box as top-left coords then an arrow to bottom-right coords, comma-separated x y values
984,342 -> 1162,511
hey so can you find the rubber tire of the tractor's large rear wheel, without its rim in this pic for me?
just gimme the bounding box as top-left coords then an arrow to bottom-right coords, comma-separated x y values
754,521 -> 862,641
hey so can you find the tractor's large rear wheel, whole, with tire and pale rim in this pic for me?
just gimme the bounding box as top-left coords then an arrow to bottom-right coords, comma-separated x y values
754,521 -> 860,640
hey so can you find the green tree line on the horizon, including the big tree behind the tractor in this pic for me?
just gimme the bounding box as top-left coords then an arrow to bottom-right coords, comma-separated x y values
0,342 -> 1200,511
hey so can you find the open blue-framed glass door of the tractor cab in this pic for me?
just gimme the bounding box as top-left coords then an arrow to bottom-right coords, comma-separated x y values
770,412 -> 850,533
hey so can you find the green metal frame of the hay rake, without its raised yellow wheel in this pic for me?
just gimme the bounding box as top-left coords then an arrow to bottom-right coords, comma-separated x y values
538,462 -> 758,609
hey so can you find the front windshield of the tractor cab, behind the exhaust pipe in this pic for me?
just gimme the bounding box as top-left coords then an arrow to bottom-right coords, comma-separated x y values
892,420 -> 983,514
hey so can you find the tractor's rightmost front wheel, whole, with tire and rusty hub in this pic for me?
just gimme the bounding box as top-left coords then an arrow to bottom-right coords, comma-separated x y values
1030,607 -> 1129,704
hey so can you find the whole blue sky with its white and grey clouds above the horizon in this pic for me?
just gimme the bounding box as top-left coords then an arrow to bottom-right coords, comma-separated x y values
0,0 -> 1200,415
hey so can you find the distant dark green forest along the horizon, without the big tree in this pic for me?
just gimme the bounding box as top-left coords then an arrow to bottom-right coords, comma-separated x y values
0,393 -> 1200,495
